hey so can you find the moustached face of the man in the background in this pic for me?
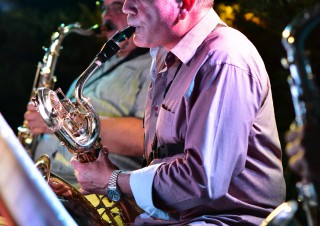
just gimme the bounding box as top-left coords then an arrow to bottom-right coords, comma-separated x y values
101,0 -> 128,38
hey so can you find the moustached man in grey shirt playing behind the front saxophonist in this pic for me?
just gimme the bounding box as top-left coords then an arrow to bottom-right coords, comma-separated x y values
25,0 -> 151,185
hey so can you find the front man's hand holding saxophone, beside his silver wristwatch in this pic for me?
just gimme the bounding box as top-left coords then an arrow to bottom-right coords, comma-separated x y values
71,147 -> 115,195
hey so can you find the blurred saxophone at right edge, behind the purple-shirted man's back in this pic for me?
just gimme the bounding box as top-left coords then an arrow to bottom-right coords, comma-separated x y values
261,4 -> 320,226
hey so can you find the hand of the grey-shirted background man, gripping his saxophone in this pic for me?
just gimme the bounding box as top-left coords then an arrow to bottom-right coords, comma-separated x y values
24,102 -> 53,135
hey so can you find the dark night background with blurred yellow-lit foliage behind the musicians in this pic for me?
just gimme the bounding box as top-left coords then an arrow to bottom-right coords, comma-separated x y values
0,0 -> 320,221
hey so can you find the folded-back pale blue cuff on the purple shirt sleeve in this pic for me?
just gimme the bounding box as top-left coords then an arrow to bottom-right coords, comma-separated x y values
130,163 -> 170,220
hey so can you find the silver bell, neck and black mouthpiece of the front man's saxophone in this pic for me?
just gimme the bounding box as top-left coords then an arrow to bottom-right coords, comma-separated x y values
32,26 -> 135,161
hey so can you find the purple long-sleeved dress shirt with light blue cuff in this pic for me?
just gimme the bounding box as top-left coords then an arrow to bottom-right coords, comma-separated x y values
130,10 -> 285,225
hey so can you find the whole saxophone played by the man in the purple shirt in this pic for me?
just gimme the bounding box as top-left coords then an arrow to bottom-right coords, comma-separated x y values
33,26 -> 141,225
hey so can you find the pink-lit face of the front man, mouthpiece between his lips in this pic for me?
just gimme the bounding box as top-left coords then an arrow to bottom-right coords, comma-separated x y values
123,0 -> 179,48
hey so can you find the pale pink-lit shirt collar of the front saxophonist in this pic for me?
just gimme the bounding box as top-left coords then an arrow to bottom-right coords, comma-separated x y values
171,9 -> 224,64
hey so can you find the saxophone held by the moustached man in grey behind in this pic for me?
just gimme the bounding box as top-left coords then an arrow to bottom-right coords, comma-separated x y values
18,22 -> 99,157
